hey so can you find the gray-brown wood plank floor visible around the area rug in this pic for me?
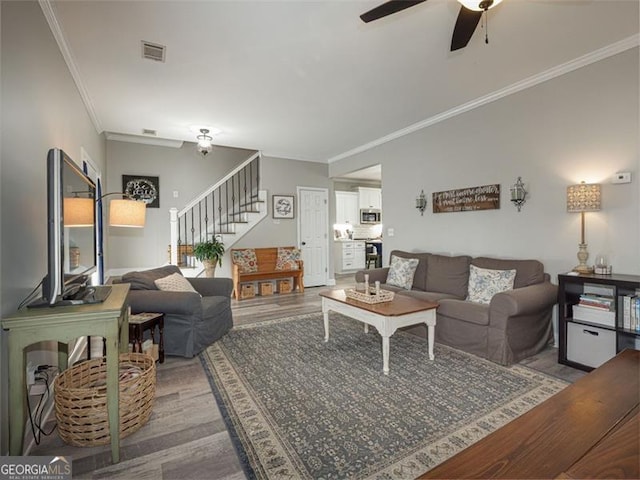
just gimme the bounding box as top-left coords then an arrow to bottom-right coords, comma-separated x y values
30,275 -> 584,480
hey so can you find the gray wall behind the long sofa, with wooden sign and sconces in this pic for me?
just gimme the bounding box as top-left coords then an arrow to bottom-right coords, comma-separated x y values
329,48 -> 640,282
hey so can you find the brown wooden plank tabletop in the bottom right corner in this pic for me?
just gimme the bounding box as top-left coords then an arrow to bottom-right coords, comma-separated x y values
419,349 -> 640,479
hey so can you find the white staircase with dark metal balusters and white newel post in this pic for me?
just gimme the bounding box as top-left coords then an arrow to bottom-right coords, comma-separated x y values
169,152 -> 267,277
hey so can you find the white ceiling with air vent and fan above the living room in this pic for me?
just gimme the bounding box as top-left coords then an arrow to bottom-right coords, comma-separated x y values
47,0 -> 639,161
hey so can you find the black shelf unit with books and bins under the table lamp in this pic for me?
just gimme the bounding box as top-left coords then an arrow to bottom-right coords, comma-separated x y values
558,274 -> 640,371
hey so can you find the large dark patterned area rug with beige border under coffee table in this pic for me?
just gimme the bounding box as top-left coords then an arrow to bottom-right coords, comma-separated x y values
201,313 -> 567,480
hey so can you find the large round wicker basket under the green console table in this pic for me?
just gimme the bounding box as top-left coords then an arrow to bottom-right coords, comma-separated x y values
54,353 -> 156,447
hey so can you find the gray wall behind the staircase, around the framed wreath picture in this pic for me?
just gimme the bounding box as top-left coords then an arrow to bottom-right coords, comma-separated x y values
105,141 -> 255,272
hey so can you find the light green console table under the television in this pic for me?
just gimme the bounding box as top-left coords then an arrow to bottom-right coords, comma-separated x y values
2,283 -> 129,463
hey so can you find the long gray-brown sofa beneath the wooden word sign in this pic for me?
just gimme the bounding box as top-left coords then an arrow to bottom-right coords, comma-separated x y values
356,250 -> 557,365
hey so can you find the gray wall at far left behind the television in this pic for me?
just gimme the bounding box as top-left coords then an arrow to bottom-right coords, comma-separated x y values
0,1 -> 105,454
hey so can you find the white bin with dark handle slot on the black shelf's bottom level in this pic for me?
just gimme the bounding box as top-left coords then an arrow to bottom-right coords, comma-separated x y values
567,322 -> 616,368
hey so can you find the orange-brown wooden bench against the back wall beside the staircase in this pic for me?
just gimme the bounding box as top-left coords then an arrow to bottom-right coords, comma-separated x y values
231,247 -> 304,300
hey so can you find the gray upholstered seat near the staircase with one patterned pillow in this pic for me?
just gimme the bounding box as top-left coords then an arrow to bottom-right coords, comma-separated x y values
113,265 -> 233,358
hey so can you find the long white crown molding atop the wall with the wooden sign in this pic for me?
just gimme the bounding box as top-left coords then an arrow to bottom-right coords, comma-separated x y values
327,34 -> 640,163
